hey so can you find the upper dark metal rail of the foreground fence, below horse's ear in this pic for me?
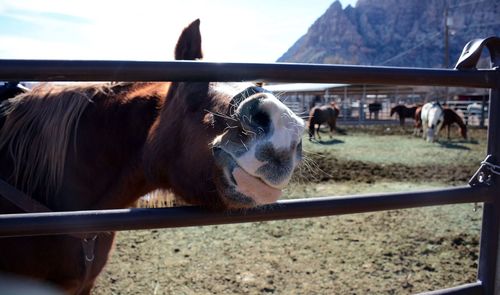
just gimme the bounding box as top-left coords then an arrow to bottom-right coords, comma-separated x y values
0,59 -> 500,88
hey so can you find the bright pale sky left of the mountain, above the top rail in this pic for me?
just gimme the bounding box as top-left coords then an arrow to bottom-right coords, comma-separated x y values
0,0 -> 357,62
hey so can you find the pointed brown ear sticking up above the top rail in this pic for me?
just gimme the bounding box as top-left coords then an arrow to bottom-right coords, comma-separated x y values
175,19 -> 203,60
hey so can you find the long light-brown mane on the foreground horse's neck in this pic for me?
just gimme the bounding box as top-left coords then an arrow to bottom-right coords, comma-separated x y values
0,84 -> 117,203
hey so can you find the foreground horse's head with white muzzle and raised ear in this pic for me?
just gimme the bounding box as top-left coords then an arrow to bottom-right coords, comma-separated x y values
144,20 -> 305,208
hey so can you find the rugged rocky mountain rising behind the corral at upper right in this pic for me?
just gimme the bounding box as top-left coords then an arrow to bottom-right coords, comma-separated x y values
278,0 -> 500,68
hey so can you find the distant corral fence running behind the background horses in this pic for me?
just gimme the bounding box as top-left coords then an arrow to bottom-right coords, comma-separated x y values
276,84 -> 489,127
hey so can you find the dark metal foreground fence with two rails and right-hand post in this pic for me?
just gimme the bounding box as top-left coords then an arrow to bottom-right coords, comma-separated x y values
0,37 -> 500,295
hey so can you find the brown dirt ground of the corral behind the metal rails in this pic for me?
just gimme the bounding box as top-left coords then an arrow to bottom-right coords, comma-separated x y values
93,127 -> 485,294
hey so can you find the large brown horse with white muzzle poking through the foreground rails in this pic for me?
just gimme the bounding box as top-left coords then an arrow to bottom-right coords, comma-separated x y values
0,20 -> 305,294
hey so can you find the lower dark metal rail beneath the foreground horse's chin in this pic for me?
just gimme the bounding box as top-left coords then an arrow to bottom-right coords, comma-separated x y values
0,186 -> 494,237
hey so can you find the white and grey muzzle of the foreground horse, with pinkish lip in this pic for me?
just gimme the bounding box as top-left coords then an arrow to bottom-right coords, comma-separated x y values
214,83 -> 305,204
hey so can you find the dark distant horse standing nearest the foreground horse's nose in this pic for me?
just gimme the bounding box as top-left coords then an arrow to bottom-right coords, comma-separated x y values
308,102 -> 340,140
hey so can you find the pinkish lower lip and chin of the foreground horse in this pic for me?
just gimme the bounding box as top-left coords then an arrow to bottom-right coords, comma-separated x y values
212,147 -> 282,209
